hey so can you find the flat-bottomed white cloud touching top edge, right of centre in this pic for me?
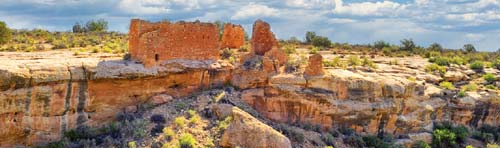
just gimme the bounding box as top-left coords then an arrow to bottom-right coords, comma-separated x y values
333,0 -> 407,16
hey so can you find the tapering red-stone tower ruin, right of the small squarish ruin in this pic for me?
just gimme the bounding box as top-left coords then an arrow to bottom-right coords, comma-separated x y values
251,19 -> 278,55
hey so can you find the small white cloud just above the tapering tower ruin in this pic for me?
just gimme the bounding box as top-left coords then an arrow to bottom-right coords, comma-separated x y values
231,3 -> 279,20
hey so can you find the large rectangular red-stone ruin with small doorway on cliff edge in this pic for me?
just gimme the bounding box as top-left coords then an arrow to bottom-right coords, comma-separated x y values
129,19 -> 220,67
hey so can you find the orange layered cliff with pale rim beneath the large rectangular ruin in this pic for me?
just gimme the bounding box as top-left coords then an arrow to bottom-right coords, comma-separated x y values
0,53 -> 233,147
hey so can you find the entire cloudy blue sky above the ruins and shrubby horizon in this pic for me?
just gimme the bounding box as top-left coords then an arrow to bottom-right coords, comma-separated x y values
0,0 -> 500,51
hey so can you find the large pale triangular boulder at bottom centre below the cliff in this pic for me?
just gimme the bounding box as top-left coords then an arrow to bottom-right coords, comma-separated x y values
220,107 -> 292,148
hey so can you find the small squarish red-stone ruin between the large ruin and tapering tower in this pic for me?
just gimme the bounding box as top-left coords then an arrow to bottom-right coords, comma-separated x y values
221,23 -> 245,48
